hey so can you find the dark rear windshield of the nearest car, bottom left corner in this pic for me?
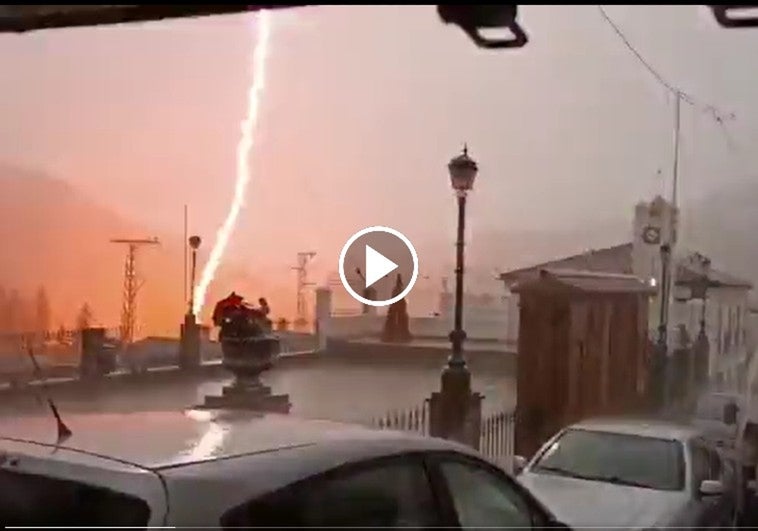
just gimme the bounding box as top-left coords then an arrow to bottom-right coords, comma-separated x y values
0,470 -> 150,528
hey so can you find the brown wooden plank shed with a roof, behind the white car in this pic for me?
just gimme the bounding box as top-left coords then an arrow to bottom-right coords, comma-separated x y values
512,269 -> 656,456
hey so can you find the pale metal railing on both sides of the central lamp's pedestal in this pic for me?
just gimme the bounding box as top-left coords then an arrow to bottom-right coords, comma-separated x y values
368,400 -> 516,470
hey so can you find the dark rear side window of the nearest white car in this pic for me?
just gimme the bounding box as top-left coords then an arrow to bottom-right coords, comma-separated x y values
221,458 -> 440,528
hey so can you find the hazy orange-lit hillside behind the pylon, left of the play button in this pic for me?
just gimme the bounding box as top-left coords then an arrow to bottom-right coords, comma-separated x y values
0,164 -> 294,334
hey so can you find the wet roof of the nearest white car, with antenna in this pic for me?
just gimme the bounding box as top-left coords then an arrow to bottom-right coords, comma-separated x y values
0,410 -> 476,470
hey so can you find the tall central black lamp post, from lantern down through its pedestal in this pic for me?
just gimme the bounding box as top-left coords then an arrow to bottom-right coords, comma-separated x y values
430,146 -> 482,448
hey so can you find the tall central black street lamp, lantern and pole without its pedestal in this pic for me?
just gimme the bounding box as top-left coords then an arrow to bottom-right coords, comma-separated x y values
447,145 -> 479,369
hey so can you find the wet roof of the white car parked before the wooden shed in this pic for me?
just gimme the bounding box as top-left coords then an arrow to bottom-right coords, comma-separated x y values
569,417 -> 702,442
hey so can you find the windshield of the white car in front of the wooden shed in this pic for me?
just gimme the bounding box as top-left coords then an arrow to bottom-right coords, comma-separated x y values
532,429 -> 684,490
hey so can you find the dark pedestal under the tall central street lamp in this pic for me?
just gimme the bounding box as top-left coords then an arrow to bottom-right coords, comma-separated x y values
429,366 -> 484,450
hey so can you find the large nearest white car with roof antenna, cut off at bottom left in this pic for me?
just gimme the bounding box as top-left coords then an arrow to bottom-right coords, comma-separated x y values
0,411 -> 566,529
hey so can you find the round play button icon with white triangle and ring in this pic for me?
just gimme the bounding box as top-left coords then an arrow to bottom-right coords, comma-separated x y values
339,227 -> 418,306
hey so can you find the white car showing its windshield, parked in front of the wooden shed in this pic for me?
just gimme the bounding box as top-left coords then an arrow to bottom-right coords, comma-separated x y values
518,418 -> 735,529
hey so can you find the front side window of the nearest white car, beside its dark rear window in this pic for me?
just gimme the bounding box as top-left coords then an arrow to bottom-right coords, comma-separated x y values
440,460 -> 534,529
